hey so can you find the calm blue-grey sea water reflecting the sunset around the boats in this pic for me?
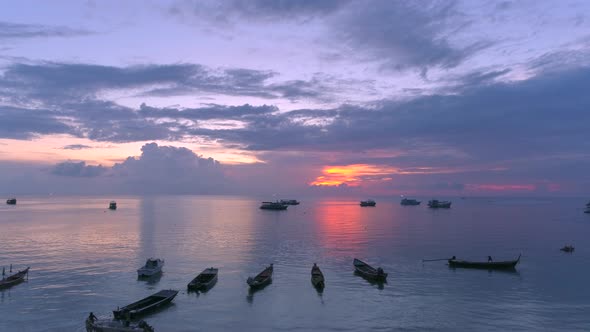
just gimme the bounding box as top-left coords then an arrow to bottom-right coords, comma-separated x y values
0,196 -> 590,331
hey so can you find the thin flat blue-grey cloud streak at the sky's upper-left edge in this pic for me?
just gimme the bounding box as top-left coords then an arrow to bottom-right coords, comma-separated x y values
0,21 -> 93,40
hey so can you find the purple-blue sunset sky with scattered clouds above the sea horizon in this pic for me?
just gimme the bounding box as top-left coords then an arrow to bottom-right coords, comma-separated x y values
0,0 -> 590,198
